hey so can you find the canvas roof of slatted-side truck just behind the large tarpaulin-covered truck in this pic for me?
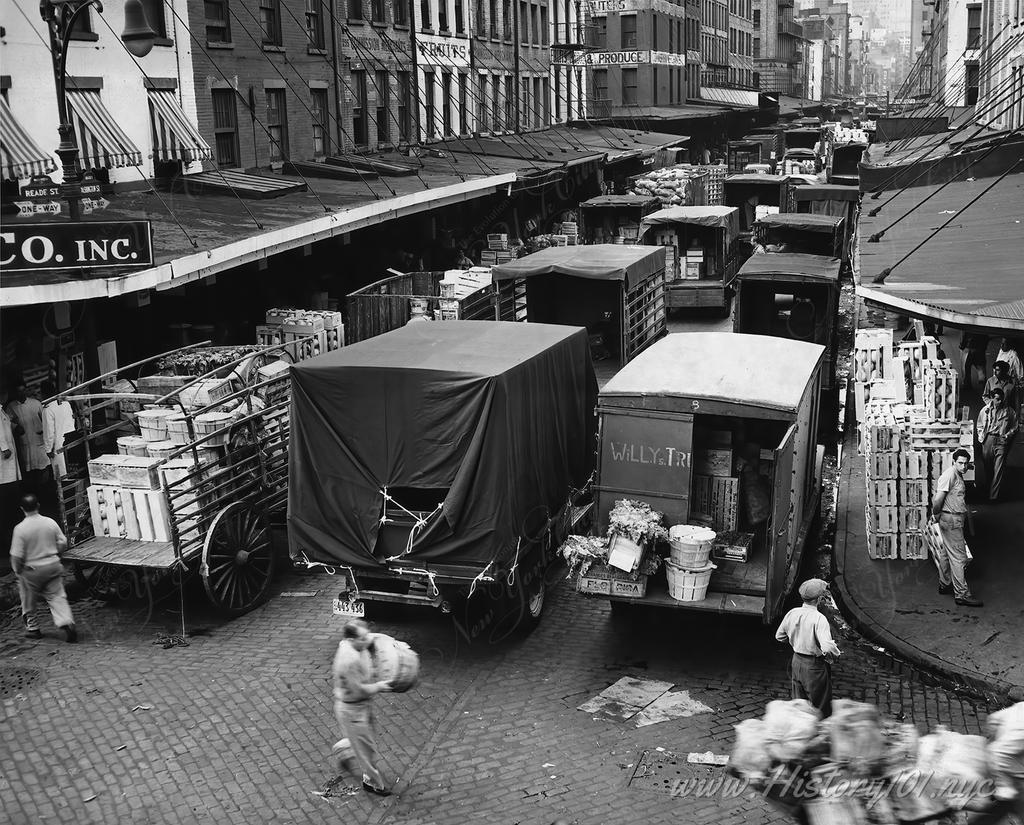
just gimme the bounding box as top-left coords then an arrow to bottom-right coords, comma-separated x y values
490,244 -> 665,290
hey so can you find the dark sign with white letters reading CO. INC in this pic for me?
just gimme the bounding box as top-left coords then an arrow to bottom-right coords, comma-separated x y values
0,221 -> 153,272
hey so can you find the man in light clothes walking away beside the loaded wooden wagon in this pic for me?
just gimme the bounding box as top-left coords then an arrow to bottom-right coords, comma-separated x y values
10,492 -> 78,642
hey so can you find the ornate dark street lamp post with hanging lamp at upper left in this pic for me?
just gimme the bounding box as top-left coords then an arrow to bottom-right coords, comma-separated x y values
39,0 -> 157,220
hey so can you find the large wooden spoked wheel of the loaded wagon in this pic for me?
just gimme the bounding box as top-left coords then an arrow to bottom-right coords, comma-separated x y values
200,502 -> 278,616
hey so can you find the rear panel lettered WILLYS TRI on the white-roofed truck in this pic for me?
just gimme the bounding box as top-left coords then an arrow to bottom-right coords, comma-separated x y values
596,406 -> 693,531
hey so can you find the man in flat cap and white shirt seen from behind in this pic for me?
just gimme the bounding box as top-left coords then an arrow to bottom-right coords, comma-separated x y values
775,578 -> 840,717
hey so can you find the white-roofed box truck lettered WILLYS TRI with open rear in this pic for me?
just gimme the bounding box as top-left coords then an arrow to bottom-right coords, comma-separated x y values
594,333 -> 824,622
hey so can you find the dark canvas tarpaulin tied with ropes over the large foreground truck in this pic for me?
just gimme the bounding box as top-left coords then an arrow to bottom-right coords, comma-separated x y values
288,321 -> 597,571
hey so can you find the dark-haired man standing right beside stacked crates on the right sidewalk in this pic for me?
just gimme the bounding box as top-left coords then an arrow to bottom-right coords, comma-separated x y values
929,448 -> 982,607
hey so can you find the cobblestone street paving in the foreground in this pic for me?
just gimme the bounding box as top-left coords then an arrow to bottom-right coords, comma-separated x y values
0,574 -> 1003,825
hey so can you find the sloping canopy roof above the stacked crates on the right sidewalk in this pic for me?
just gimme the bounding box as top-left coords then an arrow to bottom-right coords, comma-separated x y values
857,174 -> 1024,333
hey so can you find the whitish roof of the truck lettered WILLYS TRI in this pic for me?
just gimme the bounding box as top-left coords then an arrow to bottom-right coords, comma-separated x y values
599,332 -> 824,411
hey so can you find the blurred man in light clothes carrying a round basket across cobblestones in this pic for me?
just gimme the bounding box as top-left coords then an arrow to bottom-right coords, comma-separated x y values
333,619 -> 391,796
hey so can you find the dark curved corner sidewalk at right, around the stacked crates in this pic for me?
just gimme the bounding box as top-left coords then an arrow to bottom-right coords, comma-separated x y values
833,427 -> 1024,701
